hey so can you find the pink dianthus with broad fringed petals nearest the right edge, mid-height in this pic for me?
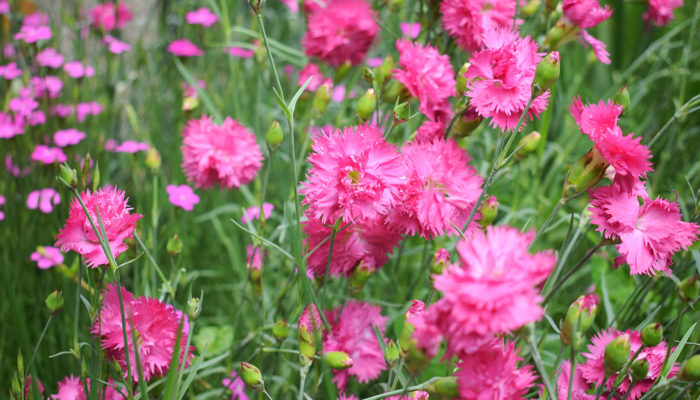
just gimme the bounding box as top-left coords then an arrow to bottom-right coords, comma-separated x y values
590,183 -> 698,275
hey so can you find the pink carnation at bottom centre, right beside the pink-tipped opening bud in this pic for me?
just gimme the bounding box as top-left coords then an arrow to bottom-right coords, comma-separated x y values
323,301 -> 386,391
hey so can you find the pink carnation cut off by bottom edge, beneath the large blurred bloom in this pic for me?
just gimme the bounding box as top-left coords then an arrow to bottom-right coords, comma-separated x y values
455,339 -> 536,399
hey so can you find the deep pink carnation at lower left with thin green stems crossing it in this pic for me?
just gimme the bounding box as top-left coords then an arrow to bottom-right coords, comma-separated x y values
92,284 -> 194,381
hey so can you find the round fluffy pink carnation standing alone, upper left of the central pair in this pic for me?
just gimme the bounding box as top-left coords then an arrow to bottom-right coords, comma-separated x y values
182,116 -> 263,189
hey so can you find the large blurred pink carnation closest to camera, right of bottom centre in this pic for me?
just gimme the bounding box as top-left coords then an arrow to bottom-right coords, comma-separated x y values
416,226 -> 556,357
